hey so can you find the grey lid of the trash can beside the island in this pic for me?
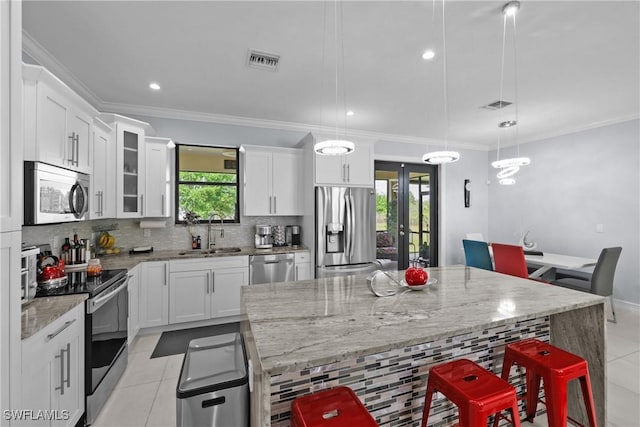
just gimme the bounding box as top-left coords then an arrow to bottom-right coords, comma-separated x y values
176,332 -> 248,399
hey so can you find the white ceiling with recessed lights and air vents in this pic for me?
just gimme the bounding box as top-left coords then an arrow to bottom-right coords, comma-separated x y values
23,0 -> 640,149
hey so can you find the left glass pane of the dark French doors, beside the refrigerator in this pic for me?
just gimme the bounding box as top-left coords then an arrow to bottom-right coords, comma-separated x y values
375,170 -> 399,270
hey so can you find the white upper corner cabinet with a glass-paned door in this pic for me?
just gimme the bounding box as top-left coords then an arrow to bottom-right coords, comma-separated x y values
101,114 -> 149,218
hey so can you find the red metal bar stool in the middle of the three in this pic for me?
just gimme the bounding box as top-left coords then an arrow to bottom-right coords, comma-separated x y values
422,359 -> 520,427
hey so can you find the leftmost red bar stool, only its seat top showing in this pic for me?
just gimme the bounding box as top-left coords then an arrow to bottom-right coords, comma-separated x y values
291,387 -> 378,427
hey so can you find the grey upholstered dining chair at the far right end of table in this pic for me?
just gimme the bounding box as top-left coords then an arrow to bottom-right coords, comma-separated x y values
551,246 -> 622,323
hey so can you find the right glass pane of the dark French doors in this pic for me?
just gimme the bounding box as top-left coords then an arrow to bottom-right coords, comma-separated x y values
408,172 -> 431,266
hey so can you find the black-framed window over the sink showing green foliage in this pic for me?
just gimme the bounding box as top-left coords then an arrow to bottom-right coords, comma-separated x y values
175,144 -> 240,224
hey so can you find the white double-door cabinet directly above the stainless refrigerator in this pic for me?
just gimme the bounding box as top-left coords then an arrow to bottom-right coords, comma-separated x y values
314,142 -> 374,187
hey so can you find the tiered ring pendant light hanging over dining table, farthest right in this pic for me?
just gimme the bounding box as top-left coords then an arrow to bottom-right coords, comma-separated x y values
491,1 -> 531,185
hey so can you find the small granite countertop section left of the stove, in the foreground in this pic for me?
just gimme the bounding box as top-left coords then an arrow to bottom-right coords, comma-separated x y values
22,294 -> 88,339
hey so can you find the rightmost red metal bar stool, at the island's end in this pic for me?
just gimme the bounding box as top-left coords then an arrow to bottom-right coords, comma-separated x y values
494,338 -> 596,427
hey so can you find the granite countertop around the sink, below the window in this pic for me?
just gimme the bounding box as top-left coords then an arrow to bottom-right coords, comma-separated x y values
100,246 -> 309,270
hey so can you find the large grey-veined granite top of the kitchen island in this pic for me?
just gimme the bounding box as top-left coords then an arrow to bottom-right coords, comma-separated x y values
242,266 -> 604,375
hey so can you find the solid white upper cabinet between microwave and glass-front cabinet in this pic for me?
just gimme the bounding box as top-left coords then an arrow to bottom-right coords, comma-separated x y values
89,118 -> 116,219
